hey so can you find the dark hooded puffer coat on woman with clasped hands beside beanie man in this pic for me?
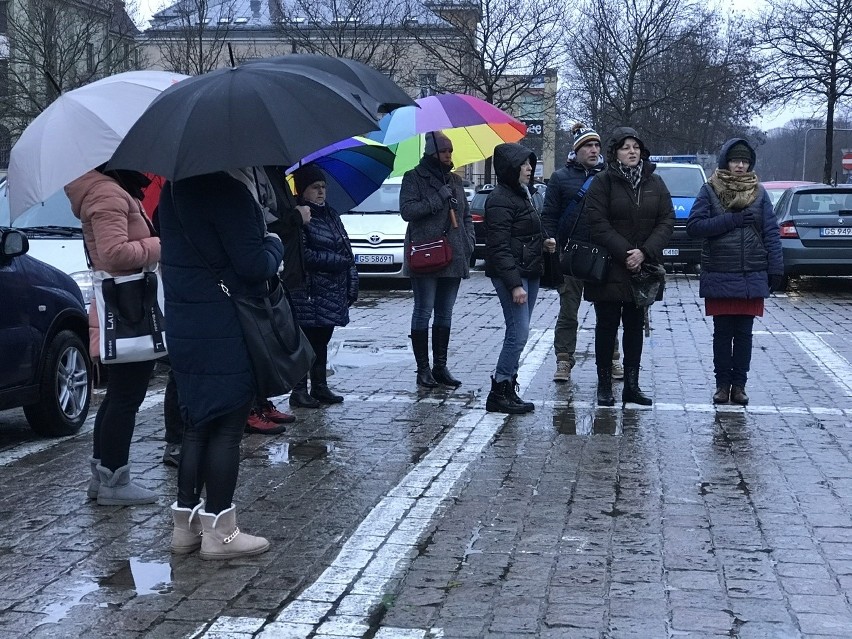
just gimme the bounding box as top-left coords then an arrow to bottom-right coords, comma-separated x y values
583,160 -> 674,302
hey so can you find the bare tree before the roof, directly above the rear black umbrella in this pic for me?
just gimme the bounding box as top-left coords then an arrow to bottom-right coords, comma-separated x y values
270,0 -> 408,76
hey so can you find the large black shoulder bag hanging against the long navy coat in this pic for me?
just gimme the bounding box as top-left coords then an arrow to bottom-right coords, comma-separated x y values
225,277 -> 316,398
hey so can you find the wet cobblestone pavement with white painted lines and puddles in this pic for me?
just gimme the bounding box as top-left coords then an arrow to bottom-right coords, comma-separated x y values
0,272 -> 852,639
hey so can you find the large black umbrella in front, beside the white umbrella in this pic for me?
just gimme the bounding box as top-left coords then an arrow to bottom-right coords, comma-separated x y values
108,63 -> 379,180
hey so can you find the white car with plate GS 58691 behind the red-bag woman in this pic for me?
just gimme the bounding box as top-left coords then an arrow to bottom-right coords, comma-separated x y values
340,177 -> 407,277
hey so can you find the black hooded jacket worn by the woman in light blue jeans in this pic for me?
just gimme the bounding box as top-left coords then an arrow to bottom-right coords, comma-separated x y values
485,144 -> 545,291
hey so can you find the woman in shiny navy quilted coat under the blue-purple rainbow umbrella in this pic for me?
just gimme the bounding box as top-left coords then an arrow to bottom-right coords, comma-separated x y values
290,164 -> 358,408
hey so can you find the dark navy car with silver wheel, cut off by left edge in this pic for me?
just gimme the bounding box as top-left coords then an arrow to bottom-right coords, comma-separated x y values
0,228 -> 92,437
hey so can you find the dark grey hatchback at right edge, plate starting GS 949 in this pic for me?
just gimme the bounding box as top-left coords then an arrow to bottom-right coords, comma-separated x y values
775,184 -> 852,288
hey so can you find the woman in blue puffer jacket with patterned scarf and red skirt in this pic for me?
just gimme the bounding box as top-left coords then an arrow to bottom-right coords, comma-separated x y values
686,138 -> 784,406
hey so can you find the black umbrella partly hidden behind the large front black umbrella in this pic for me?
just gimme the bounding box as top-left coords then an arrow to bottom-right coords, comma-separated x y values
249,53 -> 417,113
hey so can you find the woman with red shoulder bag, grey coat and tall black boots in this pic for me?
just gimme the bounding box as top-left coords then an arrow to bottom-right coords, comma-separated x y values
399,131 -> 475,388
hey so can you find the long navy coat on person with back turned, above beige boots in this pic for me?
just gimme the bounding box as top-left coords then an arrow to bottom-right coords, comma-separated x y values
159,173 -> 284,425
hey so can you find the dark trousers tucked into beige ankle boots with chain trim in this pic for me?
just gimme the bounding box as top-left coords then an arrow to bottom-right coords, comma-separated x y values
178,401 -> 252,514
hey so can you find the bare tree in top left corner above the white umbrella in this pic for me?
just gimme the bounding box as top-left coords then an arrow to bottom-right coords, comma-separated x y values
0,0 -> 139,137
